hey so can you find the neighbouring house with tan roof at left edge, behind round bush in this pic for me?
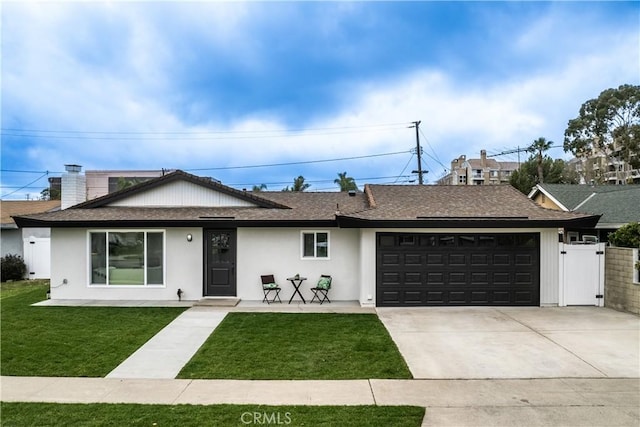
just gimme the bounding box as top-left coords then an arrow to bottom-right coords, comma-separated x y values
0,200 -> 60,279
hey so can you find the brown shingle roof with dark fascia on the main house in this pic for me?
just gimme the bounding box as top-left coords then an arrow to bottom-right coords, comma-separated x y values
16,171 -> 599,231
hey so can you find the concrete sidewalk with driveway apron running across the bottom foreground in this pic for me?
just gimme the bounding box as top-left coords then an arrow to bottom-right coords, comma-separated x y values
0,377 -> 640,426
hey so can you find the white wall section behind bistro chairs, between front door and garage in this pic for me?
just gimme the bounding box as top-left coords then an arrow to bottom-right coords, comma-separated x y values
236,228 -> 360,303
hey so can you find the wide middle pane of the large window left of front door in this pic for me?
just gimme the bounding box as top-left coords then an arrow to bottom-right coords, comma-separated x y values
109,232 -> 144,285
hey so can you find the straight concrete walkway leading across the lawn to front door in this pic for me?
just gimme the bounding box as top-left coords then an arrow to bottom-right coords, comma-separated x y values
107,307 -> 228,379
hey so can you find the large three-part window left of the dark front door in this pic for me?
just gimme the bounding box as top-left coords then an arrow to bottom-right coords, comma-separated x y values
89,231 -> 164,286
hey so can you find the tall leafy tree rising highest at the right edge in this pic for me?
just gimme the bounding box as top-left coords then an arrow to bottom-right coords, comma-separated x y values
564,84 -> 640,168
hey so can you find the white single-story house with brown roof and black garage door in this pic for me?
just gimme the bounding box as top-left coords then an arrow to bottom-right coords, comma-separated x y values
15,170 -> 599,306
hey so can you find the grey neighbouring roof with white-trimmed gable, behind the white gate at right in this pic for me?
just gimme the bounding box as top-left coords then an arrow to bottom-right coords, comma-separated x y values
529,184 -> 640,228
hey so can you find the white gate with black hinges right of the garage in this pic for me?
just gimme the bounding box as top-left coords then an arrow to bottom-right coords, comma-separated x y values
559,243 -> 605,307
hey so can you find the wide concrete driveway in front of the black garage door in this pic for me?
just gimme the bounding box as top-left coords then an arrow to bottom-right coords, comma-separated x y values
377,307 -> 640,379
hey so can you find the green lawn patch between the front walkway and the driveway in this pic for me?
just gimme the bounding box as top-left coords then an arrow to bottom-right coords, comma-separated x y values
178,313 -> 411,380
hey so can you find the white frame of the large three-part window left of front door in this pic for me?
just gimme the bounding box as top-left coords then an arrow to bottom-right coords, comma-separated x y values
86,228 -> 167,289
